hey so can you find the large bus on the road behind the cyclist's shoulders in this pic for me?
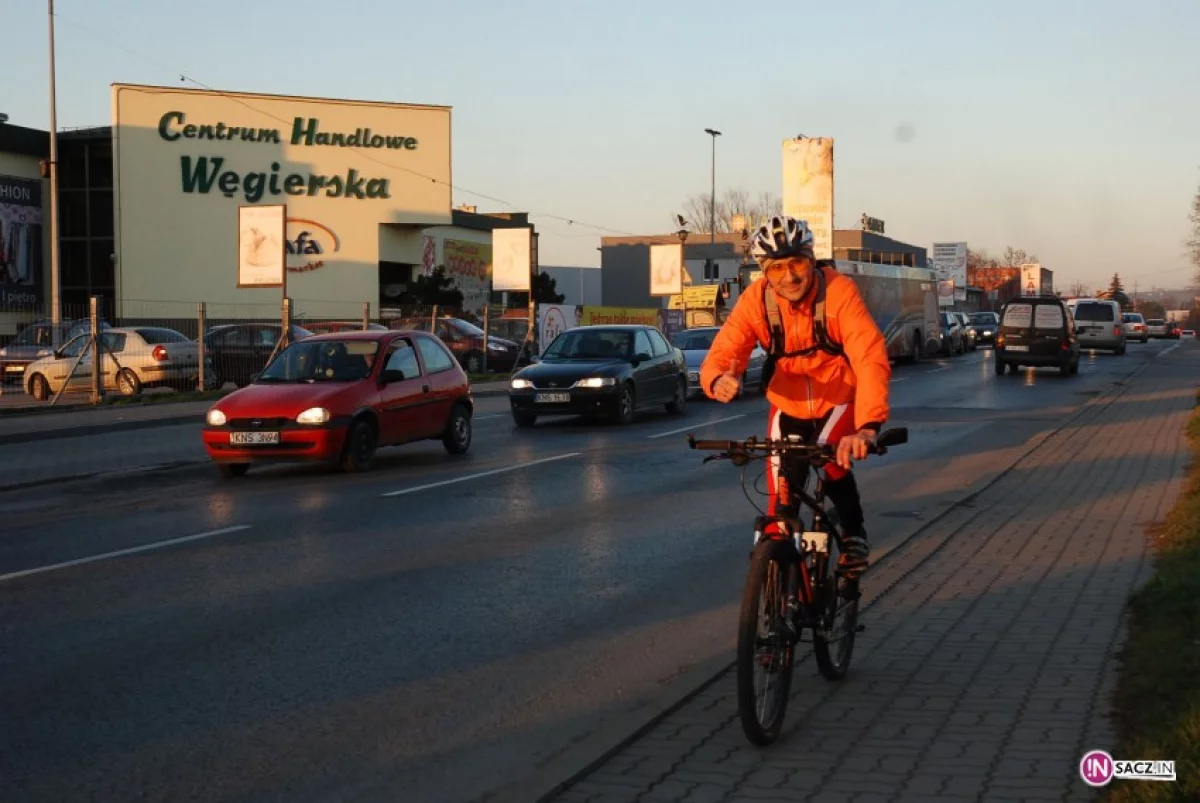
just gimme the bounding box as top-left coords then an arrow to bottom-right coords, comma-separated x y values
738,259 -> 942,362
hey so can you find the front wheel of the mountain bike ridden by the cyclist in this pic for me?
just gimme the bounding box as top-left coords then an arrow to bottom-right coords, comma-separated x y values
737,539 -> 797,745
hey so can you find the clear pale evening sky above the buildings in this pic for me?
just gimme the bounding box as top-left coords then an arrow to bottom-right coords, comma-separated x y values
0,0 -> 1200,289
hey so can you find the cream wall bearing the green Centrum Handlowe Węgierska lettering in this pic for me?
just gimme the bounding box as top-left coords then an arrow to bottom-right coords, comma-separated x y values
113,84 -> 451,316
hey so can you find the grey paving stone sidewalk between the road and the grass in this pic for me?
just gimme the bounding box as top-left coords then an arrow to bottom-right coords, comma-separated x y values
554,349 -> 1200,803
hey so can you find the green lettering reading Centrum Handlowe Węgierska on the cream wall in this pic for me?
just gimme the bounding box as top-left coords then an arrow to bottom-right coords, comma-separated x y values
158,112 -> 418,204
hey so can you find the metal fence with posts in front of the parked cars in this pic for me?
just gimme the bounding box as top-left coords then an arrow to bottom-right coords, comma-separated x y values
0,298 -> 538,403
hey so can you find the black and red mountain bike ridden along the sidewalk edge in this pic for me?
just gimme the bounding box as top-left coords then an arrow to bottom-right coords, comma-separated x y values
688,427 -> 908,745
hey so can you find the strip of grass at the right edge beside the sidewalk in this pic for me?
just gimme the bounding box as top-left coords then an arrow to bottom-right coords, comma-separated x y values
1104,396 -> 1200,803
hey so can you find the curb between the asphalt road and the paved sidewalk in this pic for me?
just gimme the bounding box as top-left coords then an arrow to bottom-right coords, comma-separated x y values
492,354 -> 1158,803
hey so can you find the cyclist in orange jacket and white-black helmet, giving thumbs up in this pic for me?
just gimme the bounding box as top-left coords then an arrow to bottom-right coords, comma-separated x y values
700,216 -> 892,570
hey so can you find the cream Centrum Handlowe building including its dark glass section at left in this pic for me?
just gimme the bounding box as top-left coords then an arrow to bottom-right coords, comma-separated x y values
0,84 -> 536,336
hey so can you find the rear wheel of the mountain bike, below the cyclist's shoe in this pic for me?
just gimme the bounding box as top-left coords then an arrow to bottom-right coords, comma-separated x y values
808,511 -> 859,681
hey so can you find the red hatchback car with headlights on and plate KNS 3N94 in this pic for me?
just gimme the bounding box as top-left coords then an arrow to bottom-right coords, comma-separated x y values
203,331 -> 474,477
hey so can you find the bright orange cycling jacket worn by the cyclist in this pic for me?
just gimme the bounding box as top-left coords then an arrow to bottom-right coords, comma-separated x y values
700,268 -> 892,430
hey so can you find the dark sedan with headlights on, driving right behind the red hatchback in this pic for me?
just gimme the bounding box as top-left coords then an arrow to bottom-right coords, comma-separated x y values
509,325 -> 688,426
